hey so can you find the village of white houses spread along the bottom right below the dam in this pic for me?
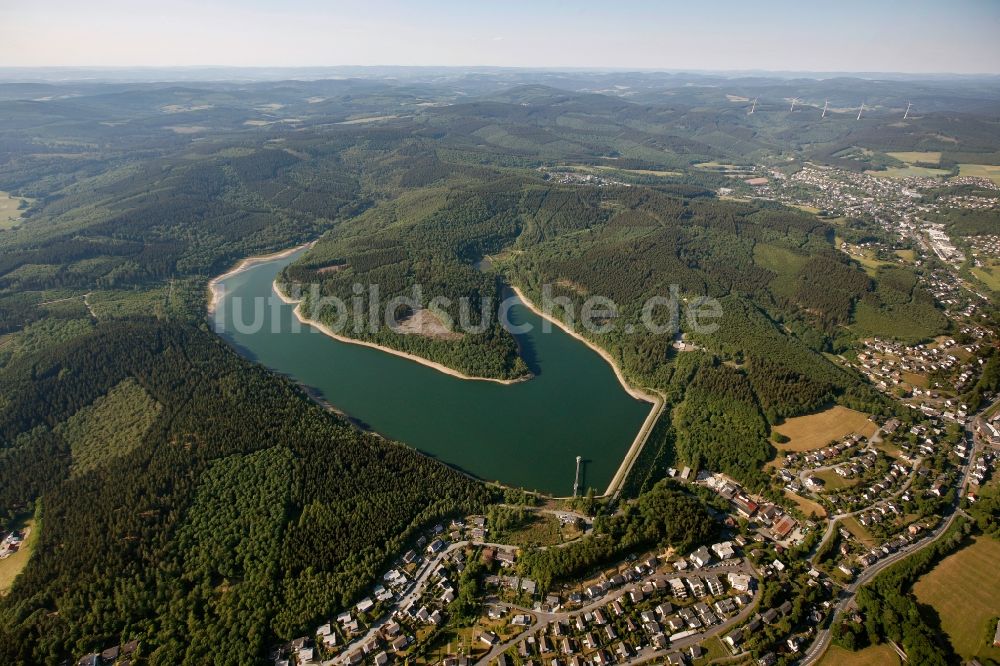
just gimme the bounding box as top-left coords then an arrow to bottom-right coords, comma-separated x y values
260,390 -> 1000,666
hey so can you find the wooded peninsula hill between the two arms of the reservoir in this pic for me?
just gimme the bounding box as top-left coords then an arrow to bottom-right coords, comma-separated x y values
283,178 -> 528,379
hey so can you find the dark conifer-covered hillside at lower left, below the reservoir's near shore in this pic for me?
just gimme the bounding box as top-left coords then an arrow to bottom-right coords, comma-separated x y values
0,320 -> 489,664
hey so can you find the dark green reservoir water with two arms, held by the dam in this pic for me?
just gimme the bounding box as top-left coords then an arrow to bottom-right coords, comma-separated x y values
217,252 -> 650,495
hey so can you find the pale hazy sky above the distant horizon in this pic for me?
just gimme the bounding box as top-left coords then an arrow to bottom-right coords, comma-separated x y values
0,0 -> 1000,73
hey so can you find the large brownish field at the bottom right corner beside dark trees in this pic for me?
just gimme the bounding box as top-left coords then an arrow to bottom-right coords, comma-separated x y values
913,536 -> 1000,661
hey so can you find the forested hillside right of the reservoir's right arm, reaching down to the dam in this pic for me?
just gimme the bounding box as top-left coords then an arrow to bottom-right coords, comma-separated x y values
497,187 -> 900,488
